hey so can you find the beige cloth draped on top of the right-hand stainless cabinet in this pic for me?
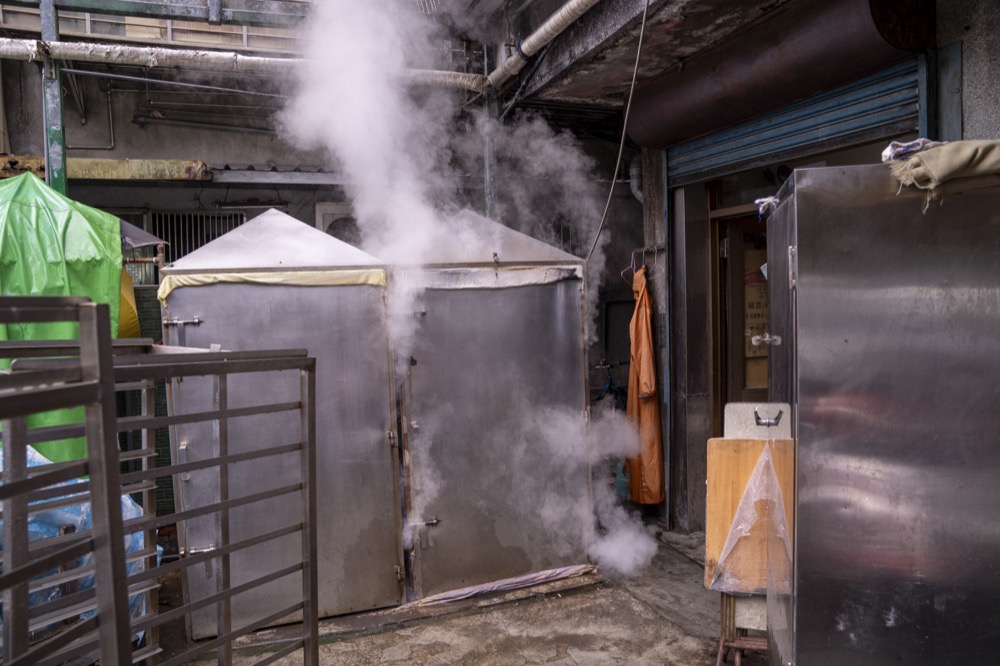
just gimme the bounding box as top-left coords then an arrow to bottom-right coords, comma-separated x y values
891,141 -> 1000,210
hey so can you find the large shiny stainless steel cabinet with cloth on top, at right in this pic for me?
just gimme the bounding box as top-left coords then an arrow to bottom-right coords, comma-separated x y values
768,165 -> 1000,666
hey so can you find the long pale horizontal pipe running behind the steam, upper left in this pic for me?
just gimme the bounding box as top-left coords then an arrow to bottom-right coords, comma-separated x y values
0,38 -> 486,92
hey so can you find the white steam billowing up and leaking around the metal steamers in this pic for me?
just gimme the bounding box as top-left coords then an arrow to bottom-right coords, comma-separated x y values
281,0 -> 656,574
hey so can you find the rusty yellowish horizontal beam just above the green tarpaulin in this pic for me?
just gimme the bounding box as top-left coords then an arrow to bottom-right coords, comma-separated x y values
0,155 -> 212,181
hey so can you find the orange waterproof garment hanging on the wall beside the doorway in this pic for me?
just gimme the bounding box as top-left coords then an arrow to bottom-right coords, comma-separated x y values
626,266 -> 664,504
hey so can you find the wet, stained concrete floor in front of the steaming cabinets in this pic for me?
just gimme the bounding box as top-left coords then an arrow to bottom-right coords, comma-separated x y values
174,533 -> 767,666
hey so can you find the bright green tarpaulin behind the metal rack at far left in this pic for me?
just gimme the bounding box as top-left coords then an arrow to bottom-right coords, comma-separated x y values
0,173 -> 122,462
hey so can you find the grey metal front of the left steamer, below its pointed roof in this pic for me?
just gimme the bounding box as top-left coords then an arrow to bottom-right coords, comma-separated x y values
167,284 -> 402,638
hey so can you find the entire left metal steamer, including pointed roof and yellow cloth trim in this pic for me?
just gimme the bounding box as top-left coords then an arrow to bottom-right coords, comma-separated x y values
160,210 -> 403,638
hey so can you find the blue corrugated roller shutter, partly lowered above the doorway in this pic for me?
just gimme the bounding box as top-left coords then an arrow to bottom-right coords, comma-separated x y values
667,59 -> 921,187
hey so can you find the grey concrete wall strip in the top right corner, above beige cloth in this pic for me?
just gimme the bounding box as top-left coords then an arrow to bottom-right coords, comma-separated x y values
937,0 -> 1000,139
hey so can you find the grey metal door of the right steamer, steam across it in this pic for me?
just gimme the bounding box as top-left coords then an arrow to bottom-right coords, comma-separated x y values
405,269 -> 591,597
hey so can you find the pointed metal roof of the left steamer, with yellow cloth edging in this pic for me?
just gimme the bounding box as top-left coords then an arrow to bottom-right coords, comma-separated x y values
158,209 -> 385,303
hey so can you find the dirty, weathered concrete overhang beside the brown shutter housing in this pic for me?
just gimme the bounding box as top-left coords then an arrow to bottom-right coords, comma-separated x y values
508,0 -> 791,112
